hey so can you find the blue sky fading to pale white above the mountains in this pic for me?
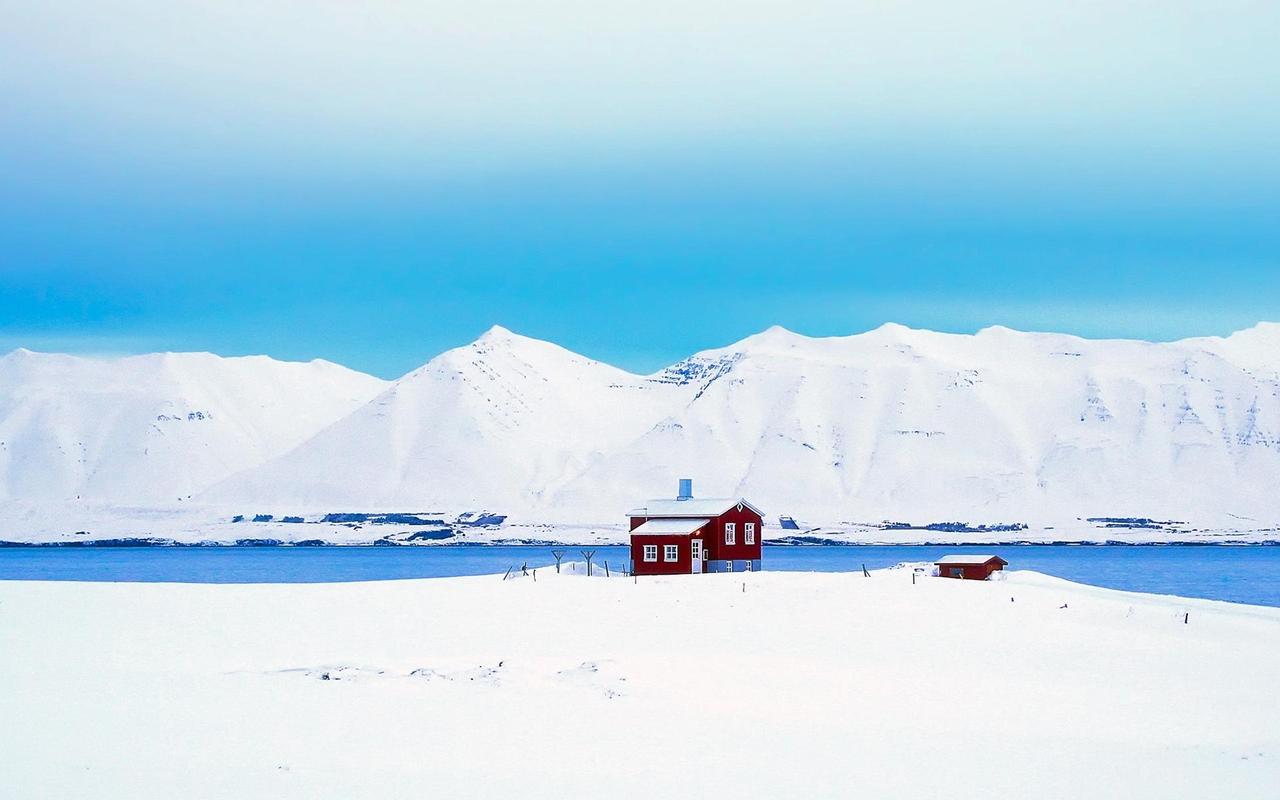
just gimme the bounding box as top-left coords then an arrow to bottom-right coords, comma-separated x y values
0,0 -> 1280,376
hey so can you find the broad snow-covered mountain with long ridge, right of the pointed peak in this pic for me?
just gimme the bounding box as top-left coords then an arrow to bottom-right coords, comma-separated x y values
549,326 -> 1280,524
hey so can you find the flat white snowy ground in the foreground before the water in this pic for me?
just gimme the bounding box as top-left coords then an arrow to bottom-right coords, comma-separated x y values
0,570 -> 1280,799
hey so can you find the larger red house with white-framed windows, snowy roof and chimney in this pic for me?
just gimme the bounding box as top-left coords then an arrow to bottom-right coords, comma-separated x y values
627,477 -> 764,575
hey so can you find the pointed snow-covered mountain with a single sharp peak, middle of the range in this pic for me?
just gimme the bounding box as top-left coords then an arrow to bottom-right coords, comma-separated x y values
202,328 -> 696,509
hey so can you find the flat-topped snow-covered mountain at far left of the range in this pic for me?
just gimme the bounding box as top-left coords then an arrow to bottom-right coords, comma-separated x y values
0,349 -> 387,506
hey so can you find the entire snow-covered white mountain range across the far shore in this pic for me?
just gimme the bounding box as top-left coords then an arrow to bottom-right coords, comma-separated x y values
0,324 -> 1280,541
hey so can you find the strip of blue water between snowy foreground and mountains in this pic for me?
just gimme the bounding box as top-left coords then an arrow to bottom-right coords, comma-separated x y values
0,545 -> 1280,607
